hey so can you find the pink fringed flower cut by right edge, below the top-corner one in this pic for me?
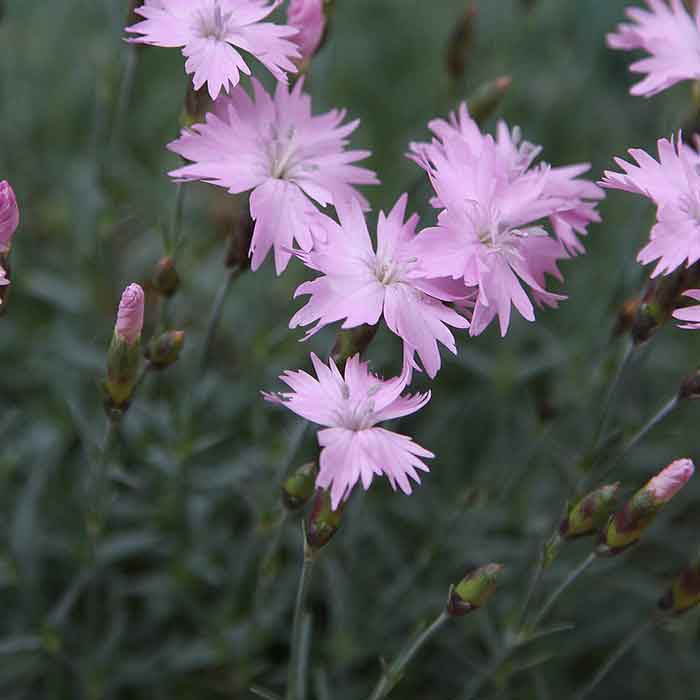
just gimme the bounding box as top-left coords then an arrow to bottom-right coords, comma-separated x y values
600,136 -> 700,277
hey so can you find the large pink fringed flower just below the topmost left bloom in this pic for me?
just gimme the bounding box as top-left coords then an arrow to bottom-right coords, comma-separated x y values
168,80 -> 378,274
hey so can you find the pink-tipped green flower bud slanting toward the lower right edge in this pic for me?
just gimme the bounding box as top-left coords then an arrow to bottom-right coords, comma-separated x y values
597,459 -> 695,556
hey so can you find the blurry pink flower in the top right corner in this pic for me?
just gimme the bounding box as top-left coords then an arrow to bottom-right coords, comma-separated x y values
607,0 -> 700,97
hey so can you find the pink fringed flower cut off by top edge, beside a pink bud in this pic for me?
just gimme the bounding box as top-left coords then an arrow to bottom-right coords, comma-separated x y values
126,0 -> 300,100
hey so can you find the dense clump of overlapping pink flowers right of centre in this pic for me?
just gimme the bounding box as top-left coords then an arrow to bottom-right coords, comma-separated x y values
410,104 -> 602,335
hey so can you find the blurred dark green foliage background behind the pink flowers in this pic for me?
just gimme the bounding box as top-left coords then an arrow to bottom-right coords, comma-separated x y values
0,0 -> 700,700
